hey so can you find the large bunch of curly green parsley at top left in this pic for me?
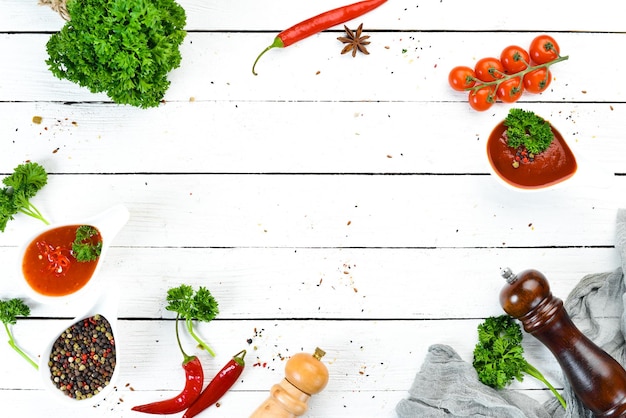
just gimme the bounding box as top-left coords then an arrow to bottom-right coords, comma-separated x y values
46,0 -> 186,108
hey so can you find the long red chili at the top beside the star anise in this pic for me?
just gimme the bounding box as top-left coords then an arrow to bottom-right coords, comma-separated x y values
252,0 -> 387,75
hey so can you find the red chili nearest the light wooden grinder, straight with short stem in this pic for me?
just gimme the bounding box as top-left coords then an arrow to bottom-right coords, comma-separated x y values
183,350 -> 246,418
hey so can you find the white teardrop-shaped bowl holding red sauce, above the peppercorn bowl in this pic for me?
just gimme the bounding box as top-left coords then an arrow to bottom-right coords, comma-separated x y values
17,205 -> 129,303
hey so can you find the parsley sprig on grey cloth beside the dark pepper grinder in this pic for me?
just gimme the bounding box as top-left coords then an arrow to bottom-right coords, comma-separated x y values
473,315 -> 565,408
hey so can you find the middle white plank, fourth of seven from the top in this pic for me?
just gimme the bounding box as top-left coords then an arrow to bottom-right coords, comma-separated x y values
0,174 -> 626,248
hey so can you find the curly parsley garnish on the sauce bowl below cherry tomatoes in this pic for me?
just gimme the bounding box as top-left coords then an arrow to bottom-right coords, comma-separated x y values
504,108 -> 554,155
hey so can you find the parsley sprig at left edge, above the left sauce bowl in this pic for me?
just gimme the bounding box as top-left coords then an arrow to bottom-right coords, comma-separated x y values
0,161 -> 48,232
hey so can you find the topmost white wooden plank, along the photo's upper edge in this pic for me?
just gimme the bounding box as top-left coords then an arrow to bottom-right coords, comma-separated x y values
0,0 -> 623,32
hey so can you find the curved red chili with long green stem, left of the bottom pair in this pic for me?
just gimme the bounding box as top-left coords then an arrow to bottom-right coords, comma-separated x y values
132,316 -> 204,414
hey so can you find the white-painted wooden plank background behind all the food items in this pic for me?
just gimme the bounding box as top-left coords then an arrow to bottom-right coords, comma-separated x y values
0,0 -> 626,418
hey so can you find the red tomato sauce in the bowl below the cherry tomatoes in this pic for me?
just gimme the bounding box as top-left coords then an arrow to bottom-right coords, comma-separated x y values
487,121 -> 578,189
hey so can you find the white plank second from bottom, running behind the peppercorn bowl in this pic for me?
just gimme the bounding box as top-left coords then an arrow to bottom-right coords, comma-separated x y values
0,319 -> 562,396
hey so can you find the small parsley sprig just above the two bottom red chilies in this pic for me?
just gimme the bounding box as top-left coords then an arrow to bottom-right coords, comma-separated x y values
165,284 -> 219,357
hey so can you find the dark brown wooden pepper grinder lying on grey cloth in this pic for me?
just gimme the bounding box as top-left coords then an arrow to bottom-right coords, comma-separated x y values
500,268 -> 626,418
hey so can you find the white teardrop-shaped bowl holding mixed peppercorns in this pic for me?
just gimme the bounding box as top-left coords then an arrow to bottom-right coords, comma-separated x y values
39,290 -> 123,408
